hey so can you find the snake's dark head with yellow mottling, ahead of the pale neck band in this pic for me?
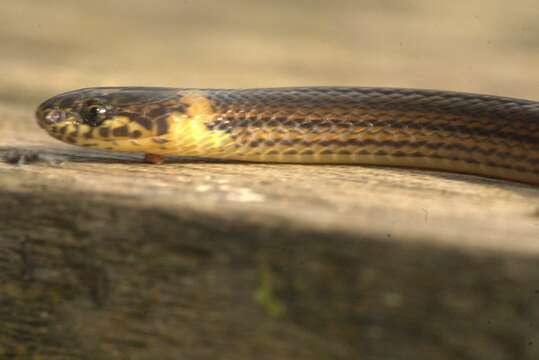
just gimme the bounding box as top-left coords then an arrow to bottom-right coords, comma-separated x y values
36,87 -> 183,151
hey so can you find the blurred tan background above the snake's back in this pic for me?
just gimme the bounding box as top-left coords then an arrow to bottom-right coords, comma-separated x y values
0,0 -> 539,104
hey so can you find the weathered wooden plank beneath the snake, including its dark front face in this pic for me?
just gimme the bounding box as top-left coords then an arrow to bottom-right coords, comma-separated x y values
0,92 -> 539,359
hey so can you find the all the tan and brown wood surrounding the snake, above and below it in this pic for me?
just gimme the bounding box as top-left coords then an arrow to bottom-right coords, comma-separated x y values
0,1 -> 539,360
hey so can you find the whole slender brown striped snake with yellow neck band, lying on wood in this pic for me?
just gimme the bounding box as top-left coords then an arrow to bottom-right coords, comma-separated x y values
36,86 -> 539,185
